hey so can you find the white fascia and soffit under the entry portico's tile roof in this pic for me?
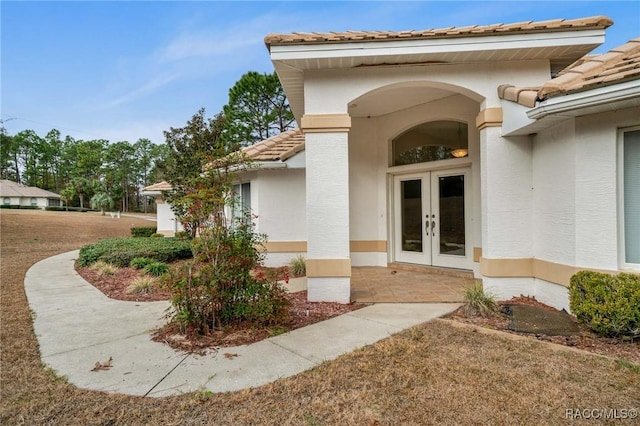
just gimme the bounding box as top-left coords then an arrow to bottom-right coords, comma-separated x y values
269,28 -> 605,122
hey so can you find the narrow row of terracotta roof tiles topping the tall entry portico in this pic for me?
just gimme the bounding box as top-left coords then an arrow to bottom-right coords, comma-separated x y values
264,16 -> 613,46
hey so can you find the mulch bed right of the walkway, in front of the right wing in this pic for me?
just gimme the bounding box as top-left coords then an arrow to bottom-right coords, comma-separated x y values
447,296 -> 640,363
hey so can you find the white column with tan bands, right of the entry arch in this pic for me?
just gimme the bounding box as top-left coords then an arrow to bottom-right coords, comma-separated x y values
476,108 -> 534,299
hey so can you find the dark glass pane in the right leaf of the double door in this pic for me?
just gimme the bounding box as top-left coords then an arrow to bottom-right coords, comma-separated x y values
438,175 -> 465,256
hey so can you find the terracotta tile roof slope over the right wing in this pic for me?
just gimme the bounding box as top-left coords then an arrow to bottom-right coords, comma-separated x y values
498,37 -> 640,107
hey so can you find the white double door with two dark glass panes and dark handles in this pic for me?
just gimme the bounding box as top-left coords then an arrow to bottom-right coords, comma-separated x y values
393,169 -> 473,269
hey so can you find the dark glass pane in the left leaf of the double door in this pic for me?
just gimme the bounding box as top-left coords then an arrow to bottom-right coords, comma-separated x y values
400,179 -> 422,252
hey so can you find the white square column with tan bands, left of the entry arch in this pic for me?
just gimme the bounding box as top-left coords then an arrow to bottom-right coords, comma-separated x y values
301,114 -> 351,303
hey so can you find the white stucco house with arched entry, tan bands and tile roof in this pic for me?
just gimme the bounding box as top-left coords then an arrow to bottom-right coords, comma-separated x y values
251,16 -> 640,308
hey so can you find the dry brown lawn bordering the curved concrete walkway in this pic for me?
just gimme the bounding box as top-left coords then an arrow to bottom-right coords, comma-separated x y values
0,210 -> 640,425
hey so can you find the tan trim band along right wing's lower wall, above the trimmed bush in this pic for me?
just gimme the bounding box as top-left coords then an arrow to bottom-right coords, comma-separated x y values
480,257 -> 619,287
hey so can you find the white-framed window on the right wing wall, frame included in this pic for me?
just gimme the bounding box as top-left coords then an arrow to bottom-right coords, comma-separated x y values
619,127 -> 640,269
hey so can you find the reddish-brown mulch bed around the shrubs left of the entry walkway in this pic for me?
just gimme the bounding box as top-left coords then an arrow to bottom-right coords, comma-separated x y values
76,264 -> 366,353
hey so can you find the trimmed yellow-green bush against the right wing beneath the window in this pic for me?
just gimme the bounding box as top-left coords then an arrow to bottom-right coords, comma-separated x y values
569,271 -> 640,338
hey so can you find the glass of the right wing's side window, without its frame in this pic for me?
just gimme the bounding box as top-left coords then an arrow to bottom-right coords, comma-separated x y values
622,130 -> 640,264
